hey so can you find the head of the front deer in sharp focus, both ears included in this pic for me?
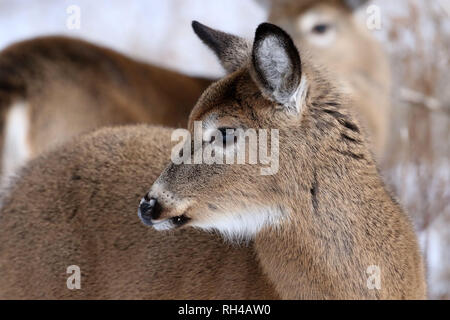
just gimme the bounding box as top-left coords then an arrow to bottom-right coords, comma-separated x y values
139,22 -> 357,239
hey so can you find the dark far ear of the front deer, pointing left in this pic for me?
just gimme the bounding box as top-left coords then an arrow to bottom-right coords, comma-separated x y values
192,21 -> 250,73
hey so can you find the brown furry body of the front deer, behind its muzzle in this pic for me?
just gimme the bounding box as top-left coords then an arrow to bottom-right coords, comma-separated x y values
0,126 -> 276,299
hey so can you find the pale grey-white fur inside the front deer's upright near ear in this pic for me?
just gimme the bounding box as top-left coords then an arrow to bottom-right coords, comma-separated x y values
257,36 -> 290,91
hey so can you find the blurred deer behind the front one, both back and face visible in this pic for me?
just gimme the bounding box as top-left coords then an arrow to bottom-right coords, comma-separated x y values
0,0 -> 390,183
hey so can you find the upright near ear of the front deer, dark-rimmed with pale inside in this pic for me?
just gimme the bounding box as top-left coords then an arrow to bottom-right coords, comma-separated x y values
252,23 -> 302,108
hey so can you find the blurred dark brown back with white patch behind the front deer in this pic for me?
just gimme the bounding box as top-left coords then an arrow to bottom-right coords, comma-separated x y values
0,37 -> 211,180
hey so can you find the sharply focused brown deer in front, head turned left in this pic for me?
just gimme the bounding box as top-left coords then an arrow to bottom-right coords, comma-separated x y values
0,21 -> 426,299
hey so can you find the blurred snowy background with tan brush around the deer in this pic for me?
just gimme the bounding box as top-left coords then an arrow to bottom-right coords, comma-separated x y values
0,0 -> 450,299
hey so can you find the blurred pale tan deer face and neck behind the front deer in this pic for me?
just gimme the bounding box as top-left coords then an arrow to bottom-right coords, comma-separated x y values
269,0 -> 391,160
